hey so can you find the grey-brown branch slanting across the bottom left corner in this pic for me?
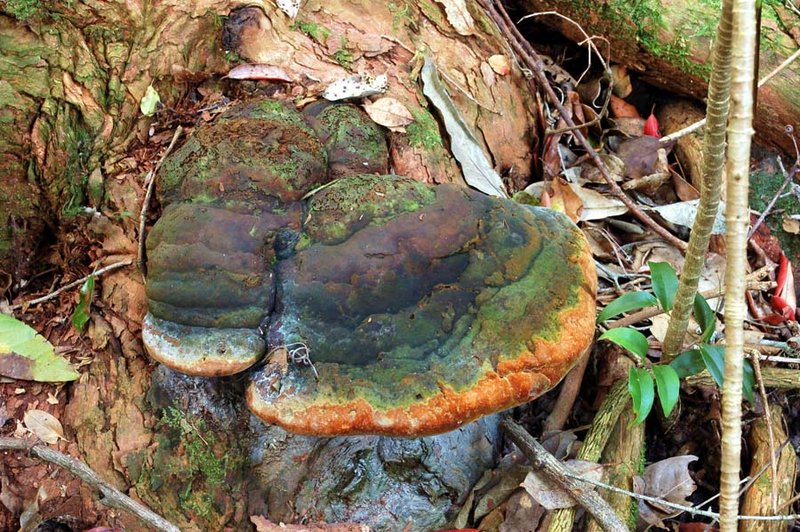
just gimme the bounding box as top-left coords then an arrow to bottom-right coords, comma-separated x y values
0,438 -> 180,532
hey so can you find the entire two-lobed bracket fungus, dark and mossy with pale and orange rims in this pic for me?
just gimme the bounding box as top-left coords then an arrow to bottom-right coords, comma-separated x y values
143,103 -> 596,437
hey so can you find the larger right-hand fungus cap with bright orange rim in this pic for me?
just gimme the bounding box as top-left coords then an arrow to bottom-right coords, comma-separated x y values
247,176 -> 597,437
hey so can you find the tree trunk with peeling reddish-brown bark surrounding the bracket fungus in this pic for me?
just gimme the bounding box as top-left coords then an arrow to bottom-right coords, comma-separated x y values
0,0 -> 537,530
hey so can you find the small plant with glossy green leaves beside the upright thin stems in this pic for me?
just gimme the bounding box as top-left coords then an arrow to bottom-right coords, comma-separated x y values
597,262 -> 754,423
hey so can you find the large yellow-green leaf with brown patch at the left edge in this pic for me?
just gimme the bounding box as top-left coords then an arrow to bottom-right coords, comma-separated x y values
0,314 -> 80,382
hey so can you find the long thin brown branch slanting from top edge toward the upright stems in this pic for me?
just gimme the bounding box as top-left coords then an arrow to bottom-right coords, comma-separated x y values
484,0 -> 686,251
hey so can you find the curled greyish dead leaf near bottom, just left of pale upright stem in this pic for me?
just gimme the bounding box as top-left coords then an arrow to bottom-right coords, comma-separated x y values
633,454 -> 697,528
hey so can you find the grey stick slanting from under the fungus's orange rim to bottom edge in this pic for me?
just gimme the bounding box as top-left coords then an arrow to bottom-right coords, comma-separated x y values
500,419 -> 627,531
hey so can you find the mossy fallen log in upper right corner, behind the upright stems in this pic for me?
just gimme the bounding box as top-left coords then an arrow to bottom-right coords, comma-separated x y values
516,0 -> 800,156
